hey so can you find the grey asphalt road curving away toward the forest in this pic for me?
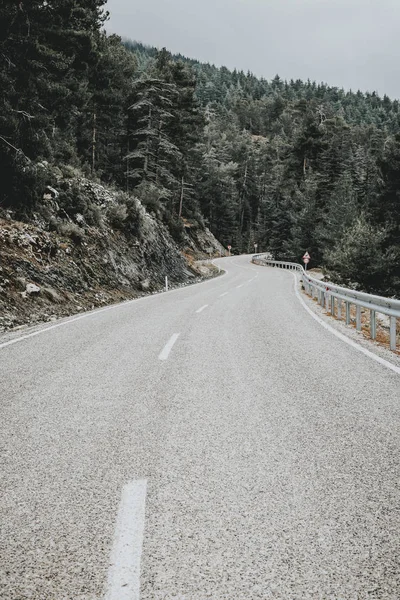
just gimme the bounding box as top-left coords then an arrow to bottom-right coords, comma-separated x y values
0,257 -> 400,600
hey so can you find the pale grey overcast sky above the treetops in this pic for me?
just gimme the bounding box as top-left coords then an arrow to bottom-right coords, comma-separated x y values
107,0 -> 400,98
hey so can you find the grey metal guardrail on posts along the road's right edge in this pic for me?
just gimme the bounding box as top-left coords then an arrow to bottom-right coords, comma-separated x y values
252,254 -> 400,351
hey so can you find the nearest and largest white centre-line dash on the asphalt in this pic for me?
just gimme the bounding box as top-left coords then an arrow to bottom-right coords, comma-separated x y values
105,479 -> 147,600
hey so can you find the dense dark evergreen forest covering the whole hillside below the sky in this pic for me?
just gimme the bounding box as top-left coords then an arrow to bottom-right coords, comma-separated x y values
0,0 -> 400,295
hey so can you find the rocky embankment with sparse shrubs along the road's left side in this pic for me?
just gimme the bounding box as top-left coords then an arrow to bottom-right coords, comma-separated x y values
0,178 -> 225,331
